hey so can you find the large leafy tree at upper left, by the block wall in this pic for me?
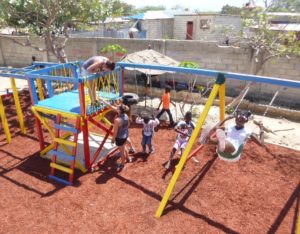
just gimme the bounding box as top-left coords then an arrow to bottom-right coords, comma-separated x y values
0,0 -> 126,62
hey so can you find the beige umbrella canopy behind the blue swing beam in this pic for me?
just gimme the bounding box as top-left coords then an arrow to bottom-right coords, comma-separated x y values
122,49 -> 179,75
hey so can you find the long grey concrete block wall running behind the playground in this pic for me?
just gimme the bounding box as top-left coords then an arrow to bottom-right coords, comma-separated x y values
0,37 -> 300,106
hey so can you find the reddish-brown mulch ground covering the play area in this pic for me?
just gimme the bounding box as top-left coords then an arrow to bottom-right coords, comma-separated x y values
0,90 -> 300,233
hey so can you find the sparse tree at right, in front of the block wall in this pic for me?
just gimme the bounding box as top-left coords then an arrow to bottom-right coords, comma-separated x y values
227,8 -> 300,108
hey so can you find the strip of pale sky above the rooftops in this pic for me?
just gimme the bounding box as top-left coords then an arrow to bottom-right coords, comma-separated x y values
123,0 -> 257,11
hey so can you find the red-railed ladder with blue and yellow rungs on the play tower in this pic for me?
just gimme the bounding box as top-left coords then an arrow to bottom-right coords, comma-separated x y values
49,114 -> 81,185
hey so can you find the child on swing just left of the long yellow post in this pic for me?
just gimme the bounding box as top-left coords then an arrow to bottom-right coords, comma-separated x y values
165,111 -> 195,169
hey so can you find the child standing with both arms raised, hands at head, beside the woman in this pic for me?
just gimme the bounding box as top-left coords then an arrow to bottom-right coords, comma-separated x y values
136,116 -> 159,154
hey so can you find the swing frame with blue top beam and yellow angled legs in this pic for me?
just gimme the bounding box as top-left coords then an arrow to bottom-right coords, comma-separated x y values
118,62 -> 300,220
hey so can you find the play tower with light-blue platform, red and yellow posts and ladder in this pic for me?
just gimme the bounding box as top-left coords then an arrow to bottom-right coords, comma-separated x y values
0,62 -> 123,185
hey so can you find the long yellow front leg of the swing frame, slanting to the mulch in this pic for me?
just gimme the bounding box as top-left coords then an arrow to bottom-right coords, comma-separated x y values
155,84 -> 220,218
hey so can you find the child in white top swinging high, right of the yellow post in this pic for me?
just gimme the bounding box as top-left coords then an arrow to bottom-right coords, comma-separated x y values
209,110 -> 264,162
